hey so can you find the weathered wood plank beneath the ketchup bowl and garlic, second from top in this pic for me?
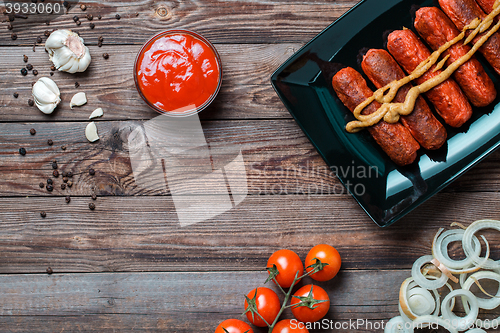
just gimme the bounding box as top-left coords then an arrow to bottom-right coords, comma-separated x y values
0,44 -> 301,121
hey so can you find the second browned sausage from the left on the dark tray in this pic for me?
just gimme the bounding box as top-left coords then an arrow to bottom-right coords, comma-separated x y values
361,49 -> 446,149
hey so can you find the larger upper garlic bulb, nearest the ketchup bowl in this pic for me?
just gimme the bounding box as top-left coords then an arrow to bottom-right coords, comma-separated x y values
45,29 -> 90,73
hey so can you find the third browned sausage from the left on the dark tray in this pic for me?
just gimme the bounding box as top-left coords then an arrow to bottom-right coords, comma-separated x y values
387,29 -> 472,127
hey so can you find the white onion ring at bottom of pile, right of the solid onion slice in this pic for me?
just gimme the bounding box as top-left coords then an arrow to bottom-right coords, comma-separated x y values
441,289 -> 479,331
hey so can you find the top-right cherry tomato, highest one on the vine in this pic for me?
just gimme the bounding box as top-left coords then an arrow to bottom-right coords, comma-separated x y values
305,244 -> 341,281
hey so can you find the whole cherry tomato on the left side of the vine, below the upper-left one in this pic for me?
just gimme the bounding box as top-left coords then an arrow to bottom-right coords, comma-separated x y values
245,287 -> 281,327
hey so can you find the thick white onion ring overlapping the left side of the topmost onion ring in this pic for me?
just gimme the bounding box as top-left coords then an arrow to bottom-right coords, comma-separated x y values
432,228 -> 481,273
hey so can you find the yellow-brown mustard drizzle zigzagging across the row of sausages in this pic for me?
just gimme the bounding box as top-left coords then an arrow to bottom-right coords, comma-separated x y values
346,0 -> 500,133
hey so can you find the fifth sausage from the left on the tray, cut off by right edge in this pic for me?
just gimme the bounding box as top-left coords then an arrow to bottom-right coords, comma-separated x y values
439,0 -> 500,74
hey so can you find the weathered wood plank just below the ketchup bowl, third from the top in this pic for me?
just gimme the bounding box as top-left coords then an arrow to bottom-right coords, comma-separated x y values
0,120 -> 500,196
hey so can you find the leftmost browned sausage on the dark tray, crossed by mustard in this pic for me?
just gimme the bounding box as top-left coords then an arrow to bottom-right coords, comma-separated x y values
332,67 -> 420,166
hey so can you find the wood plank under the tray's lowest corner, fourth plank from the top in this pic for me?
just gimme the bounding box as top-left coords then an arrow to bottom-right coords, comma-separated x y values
0,193 -> 500,274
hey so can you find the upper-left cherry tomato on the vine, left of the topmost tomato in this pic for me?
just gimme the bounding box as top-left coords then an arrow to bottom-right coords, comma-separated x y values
267,250 -> 304,288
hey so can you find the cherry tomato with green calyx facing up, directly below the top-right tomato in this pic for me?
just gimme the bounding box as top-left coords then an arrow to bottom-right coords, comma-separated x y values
290,284 -> 330,323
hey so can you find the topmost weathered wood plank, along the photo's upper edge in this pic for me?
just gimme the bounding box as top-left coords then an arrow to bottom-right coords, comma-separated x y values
0,0 -> 358,46
